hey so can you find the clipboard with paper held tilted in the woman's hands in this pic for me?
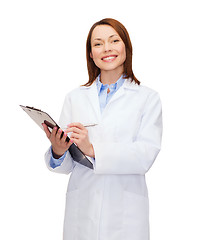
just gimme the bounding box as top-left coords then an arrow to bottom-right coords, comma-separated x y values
20,105 -> 93,169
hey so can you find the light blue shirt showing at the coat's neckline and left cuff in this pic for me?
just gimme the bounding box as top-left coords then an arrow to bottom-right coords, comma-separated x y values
50,75 -> 125,168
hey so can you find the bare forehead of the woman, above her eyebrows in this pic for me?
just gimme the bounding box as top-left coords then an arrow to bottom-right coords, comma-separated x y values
91,25 -> 119,41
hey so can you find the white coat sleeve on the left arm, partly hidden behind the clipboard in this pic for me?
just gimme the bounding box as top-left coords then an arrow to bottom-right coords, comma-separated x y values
45,95 -> 75,174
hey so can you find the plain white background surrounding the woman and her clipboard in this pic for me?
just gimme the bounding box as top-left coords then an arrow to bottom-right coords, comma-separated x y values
0,0 -> 201,240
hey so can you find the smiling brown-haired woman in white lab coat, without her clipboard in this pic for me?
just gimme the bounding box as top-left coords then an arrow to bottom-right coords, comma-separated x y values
44,19 -> 162,240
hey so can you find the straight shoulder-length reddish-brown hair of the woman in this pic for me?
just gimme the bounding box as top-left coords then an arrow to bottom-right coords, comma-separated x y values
84,18 -> 140,86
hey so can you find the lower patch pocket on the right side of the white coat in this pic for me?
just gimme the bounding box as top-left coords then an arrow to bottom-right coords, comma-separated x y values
123,191 -> 149,240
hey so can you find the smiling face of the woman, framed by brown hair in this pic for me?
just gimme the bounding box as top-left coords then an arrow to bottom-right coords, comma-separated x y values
90,25 -> 126,74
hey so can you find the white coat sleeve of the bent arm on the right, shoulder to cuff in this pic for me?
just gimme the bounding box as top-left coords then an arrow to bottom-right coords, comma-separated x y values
93,92 -> 162,175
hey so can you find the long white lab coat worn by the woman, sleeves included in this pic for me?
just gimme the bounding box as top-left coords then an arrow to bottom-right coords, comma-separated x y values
45,79 -> 162,240
